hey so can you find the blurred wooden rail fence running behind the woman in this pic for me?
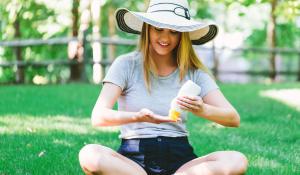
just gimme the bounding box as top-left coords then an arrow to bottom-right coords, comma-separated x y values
0,37 -> 300,81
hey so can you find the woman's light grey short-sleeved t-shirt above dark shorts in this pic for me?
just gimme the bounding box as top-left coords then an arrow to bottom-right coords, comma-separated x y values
103,51 -> 218,139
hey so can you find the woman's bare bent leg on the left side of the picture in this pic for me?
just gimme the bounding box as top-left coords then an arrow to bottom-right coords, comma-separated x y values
79,144 -> 147,175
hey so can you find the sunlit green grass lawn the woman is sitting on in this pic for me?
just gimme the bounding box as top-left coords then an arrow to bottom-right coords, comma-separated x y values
0,83 -> 300,175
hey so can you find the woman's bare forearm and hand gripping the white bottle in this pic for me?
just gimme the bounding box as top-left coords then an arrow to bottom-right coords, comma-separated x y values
177,90 -> 240,127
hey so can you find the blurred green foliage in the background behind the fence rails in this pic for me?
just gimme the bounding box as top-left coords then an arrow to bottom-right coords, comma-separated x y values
0,0 -> 300,83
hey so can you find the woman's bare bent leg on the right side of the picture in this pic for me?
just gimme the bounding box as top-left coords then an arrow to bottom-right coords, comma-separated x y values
174,151 -> 248,175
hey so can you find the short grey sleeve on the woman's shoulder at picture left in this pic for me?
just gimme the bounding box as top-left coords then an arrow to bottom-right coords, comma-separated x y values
102,56 -> 130,91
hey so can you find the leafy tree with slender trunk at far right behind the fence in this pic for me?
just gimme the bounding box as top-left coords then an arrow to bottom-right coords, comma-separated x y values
214,0 -> 300,81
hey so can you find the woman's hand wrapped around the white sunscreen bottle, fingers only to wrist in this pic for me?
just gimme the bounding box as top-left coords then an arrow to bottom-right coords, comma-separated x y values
176,96 -> 204,114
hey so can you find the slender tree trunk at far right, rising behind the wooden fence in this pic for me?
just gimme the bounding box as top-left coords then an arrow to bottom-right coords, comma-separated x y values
268,0 -> 278,81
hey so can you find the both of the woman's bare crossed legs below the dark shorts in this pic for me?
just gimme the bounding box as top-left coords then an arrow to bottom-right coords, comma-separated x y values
79,144 -> 247,175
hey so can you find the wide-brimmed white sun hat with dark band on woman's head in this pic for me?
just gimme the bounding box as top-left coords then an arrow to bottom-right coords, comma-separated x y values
115,0 -> 218,45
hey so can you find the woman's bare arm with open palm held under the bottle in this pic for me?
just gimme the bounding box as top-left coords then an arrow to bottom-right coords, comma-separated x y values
92,83 -> 170,126
